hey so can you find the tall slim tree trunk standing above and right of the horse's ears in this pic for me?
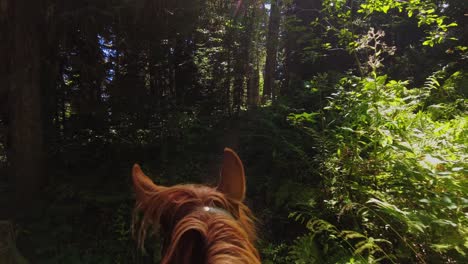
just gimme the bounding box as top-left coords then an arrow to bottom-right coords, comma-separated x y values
262,0 -> 281,103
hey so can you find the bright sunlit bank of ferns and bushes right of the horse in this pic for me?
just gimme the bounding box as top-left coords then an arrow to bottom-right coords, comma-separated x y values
290,67 -> 468,263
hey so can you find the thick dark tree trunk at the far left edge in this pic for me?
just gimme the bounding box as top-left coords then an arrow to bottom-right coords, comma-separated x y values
8,0 -> 45,214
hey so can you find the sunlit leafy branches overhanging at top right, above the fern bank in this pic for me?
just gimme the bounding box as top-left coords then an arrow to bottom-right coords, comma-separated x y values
306,0 -> 464,82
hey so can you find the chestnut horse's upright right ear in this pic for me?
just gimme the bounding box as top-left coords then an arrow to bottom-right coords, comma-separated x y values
217,148 -> 245,202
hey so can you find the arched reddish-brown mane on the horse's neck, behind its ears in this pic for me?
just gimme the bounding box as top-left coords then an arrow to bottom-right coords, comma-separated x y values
161,211 -> 260,264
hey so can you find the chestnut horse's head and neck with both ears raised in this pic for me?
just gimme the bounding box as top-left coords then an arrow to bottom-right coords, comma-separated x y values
133,148 -> 260,264
